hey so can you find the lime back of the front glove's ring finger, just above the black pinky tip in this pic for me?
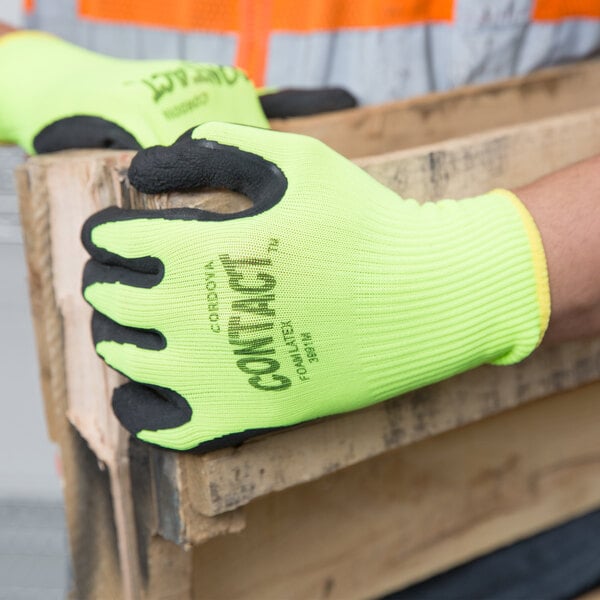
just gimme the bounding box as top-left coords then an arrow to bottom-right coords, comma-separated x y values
96,340 -> 165,385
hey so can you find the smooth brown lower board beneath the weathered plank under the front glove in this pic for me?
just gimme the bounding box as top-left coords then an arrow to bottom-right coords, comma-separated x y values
193,383 -> 600,600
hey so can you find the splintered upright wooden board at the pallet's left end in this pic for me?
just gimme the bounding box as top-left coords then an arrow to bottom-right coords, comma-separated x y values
17,153 -> 140,599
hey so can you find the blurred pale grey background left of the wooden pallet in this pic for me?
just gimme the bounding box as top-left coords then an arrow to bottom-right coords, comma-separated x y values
0,0 -> 68,600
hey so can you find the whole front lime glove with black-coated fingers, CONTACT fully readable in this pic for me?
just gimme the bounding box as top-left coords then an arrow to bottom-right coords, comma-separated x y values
82,123 -> 549,450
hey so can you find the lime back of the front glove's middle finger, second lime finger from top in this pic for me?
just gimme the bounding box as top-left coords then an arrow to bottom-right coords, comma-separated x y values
83,276 -> 160,329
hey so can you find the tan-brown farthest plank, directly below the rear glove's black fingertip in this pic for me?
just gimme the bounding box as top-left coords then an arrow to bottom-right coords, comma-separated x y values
271,60 -> 600,158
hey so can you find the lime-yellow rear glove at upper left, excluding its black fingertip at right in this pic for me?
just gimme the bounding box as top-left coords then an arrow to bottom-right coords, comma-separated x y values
0,31 -> 268,154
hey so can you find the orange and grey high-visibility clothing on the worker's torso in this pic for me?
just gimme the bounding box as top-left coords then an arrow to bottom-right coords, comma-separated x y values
24,0 -> 600,102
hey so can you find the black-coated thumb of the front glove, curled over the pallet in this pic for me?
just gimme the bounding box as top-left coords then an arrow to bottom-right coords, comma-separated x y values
129,131 -> 288,221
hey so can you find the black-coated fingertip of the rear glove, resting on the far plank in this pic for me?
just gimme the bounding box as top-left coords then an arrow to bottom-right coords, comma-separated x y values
260,88 -> 358,119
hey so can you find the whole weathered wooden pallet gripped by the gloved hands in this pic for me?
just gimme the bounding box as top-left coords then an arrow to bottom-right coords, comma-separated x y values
17,58 -> 600,598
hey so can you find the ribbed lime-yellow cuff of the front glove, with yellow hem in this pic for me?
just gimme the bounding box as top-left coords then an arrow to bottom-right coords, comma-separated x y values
358,190 -> 550,399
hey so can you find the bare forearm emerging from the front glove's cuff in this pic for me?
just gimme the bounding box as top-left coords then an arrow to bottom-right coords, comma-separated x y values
514,156 -> 600,343
